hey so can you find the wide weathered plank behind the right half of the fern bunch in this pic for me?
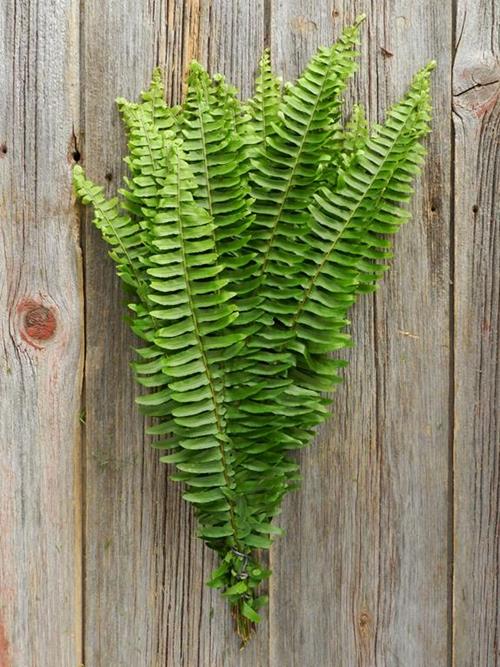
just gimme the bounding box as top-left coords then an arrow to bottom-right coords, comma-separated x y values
270,0 -> 451,667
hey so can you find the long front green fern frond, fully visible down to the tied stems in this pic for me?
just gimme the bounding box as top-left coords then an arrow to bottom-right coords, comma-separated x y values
141,144 -> 274,616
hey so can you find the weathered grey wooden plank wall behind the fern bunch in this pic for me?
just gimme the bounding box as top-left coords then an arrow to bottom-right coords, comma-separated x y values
0,0 -> 500,667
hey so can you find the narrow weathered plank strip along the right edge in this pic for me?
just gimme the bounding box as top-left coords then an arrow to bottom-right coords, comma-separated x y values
453,0 -> 500,667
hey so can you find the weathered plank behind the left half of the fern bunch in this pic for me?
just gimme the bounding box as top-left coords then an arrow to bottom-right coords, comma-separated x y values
83,0 -> 268,667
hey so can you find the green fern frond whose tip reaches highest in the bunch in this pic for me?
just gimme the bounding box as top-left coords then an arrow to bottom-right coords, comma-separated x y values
252,16 -> 359,279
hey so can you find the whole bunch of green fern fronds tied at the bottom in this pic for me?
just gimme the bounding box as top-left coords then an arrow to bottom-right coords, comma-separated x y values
74,14 -> 433,642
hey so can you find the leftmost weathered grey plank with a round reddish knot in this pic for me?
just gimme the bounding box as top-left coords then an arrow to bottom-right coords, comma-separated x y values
0,0 -> 83,667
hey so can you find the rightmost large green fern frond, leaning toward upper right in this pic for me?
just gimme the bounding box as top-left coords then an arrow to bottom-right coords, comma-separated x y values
276,68 -> 436,353
